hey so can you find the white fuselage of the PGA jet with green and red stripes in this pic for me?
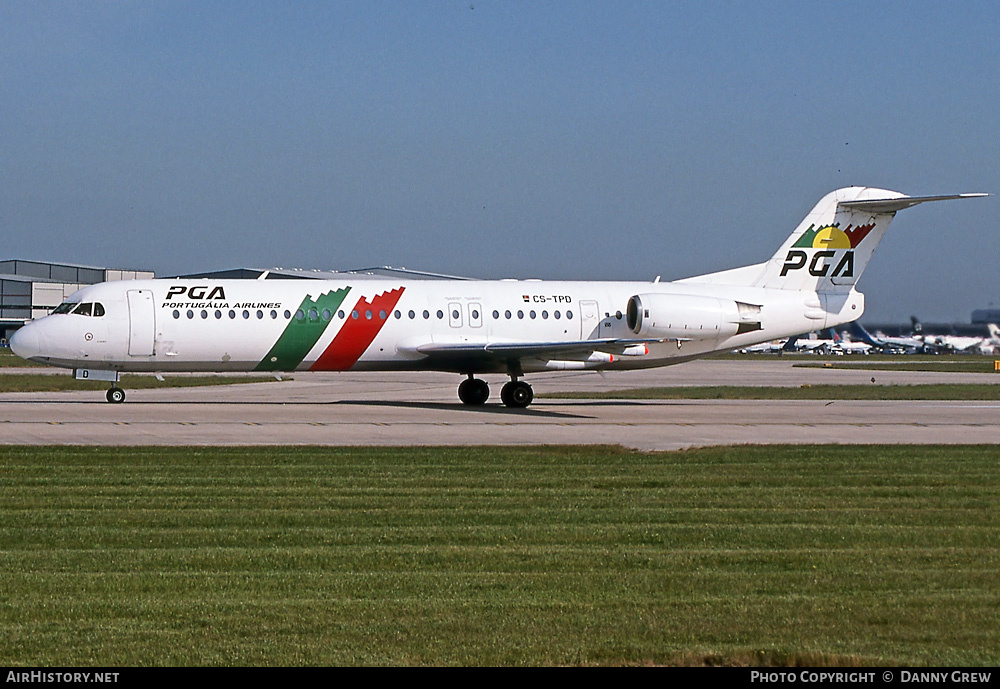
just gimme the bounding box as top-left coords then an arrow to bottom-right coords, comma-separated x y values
11,278 -> 864,373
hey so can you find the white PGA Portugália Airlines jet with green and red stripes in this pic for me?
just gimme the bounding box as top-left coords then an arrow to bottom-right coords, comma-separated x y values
10,187 -> 985,407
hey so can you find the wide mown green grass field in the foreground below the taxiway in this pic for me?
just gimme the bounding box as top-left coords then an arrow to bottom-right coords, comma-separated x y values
0,446 -> 1000,666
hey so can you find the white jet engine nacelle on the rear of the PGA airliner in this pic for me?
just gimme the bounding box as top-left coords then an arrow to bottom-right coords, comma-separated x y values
626,294 -> 760,340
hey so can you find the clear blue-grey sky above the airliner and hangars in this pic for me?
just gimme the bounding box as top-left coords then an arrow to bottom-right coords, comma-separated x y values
0,0 -> 1000,321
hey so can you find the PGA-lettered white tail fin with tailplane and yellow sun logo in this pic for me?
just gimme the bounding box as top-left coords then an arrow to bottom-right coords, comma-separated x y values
680,187 -> 986,293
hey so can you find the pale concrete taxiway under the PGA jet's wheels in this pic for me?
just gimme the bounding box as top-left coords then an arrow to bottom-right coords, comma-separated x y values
0,357 -> 1000,450
